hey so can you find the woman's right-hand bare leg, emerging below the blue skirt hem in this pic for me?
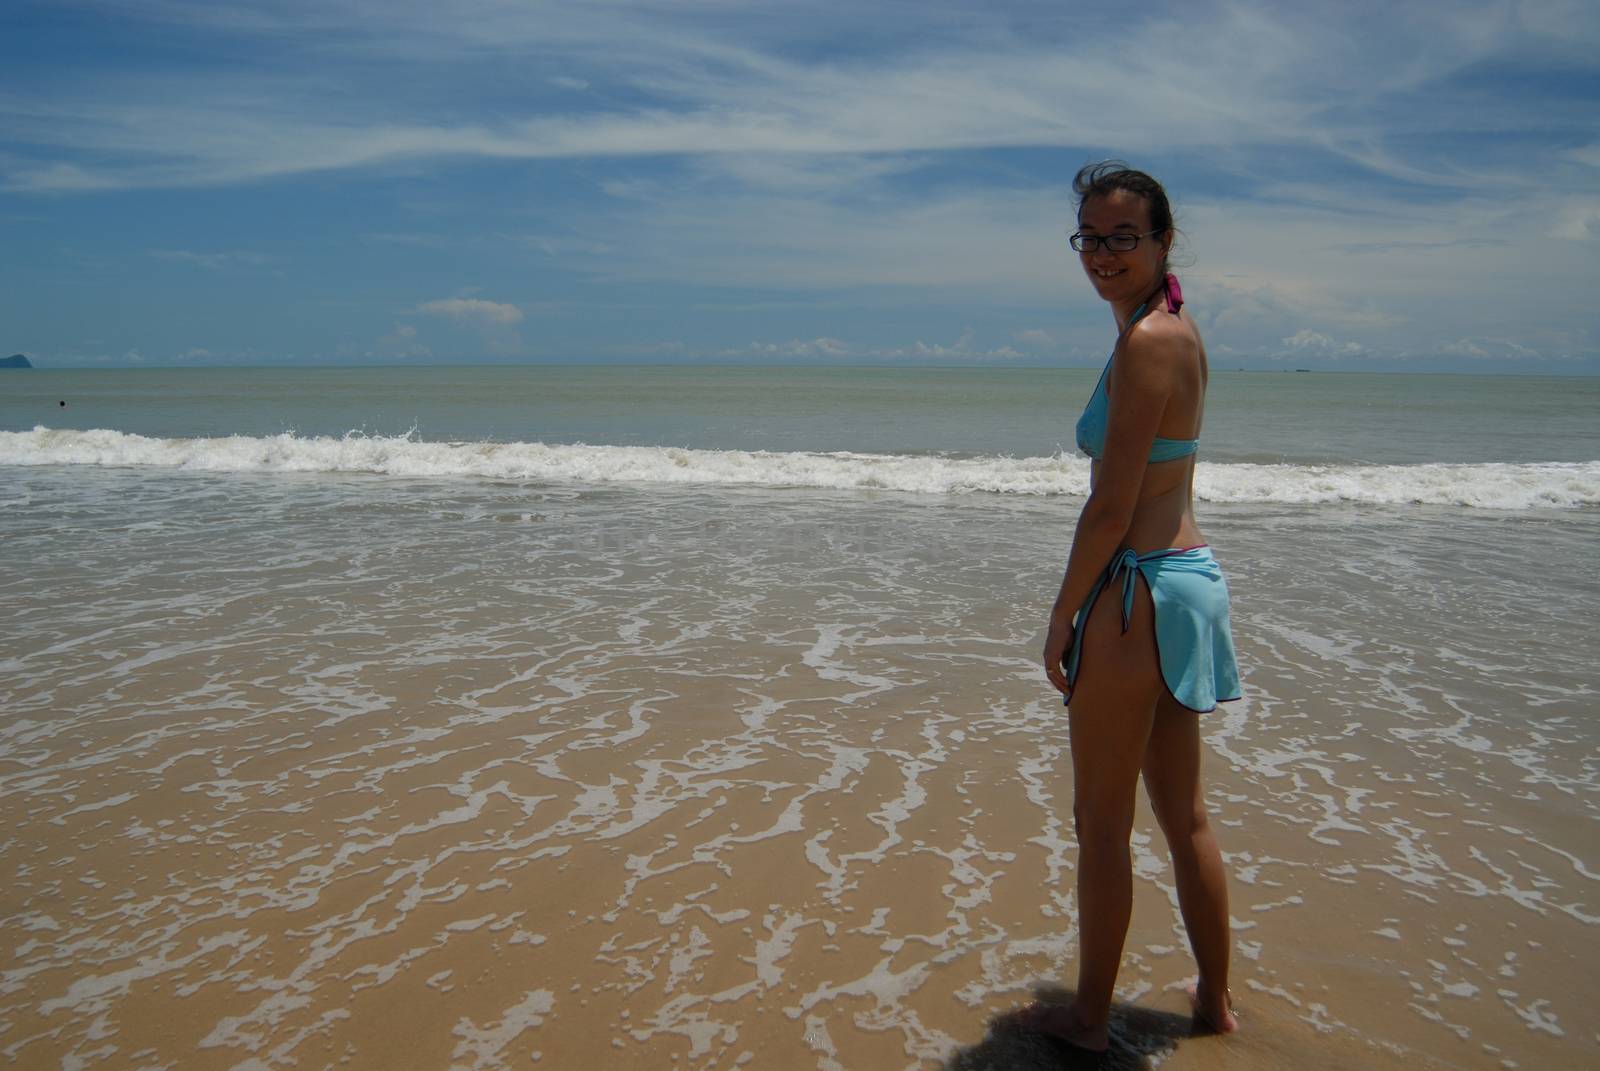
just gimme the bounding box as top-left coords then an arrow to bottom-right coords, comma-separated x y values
1144,692 -> 1237,1033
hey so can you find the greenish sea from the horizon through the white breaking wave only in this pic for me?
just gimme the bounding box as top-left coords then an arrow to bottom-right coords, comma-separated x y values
0,365 -> 1600,496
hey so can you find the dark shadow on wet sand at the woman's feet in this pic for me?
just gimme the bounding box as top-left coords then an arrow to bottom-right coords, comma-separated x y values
944,986 -> 1194,1071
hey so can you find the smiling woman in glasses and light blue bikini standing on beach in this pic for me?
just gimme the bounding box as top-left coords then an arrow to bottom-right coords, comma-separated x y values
1027,162 -> 1238,1050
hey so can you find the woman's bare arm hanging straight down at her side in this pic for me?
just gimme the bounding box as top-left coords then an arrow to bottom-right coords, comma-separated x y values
1045,323 -> 1194,695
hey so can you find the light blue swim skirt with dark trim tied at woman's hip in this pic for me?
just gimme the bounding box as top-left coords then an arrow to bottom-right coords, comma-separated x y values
1067,544 -> 1240,714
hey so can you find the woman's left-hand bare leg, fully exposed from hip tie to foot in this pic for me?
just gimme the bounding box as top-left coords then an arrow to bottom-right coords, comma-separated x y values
1050,581 -> 1162,1049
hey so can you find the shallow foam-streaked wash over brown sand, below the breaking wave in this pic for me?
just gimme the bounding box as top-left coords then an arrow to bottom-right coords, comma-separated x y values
0,469 -> 1600,1068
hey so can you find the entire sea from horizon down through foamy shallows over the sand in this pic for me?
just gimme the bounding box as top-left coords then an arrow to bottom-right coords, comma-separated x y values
0,365 -> 1600,1069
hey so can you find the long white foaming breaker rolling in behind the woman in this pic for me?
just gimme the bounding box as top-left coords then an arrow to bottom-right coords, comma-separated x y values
0,427 -> 1600,509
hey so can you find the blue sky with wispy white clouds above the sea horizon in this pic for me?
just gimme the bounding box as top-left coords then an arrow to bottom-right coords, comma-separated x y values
0,0 -> 1600,375
